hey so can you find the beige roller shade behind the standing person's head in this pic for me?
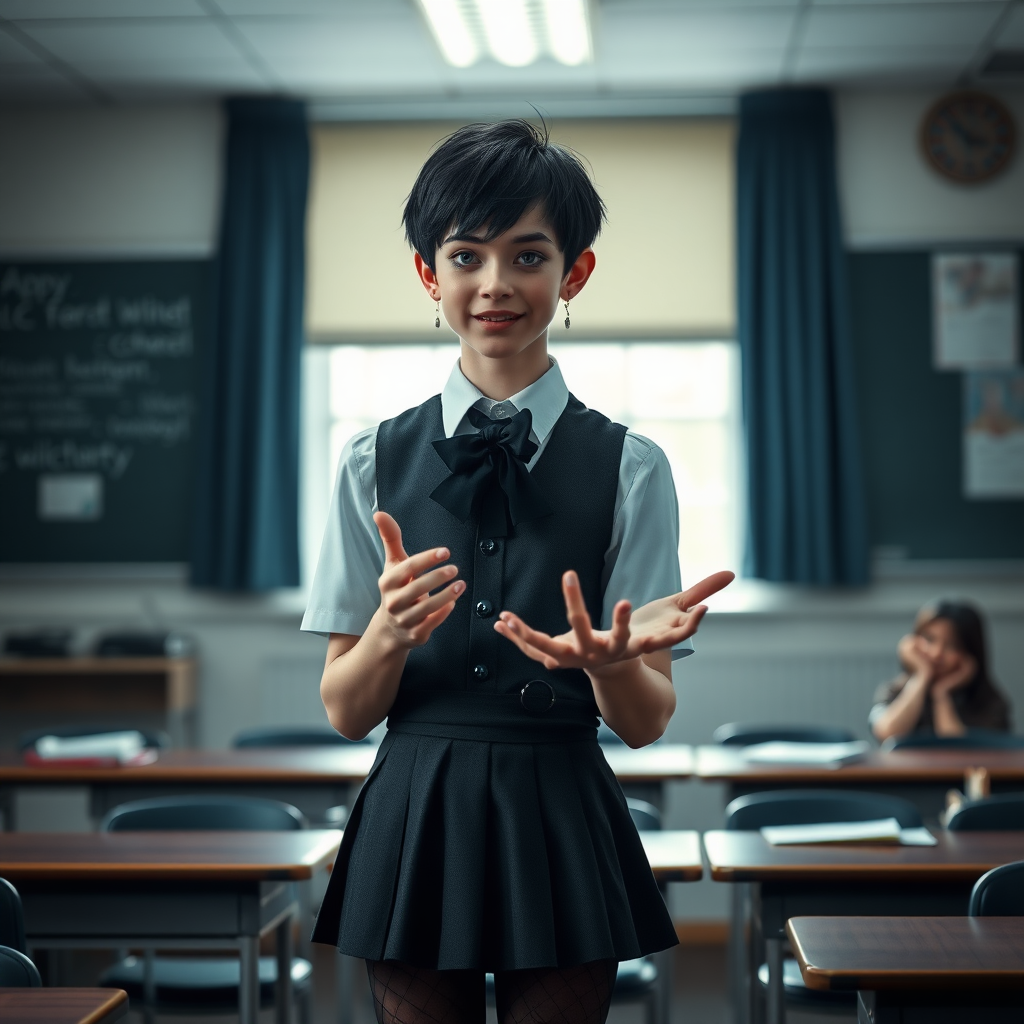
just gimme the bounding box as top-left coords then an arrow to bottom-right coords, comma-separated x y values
306,119 -> 734,342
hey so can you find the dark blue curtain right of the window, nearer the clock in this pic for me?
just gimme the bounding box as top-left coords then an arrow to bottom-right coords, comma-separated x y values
736,89 -> 868,586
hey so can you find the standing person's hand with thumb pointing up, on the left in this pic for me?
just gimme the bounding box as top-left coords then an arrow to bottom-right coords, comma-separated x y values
374,512 -> 466,647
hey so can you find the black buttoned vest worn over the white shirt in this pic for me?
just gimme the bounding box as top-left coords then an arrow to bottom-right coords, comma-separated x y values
377,395 -> 626,710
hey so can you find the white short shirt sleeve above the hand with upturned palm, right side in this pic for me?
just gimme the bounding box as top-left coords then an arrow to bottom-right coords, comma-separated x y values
601,431 -> 693,660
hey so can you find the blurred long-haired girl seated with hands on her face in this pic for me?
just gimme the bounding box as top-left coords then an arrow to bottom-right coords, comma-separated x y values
868,601 -> 1010,740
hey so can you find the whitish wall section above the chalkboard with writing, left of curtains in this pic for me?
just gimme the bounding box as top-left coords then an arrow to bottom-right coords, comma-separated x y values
0,103 -> 222,258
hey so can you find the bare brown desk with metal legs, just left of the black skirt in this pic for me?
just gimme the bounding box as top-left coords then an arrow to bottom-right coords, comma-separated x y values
0,830 -> 341,1024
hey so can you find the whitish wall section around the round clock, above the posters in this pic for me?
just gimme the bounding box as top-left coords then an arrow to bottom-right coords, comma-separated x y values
836,89 -> 1024,249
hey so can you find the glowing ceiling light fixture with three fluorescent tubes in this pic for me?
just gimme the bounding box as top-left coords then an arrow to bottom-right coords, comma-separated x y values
419,0 -> 593,68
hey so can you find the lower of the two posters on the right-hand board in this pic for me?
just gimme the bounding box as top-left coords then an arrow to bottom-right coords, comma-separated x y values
964,370 -> 1024,499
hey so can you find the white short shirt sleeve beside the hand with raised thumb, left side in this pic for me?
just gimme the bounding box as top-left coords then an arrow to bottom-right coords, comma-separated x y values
300,427 -> 384,636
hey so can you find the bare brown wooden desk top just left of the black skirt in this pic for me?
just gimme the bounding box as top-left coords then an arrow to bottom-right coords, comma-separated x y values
0,829 -> 341,880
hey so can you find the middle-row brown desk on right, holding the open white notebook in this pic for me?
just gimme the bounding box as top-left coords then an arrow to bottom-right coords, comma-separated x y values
703,829 -> 1024,1024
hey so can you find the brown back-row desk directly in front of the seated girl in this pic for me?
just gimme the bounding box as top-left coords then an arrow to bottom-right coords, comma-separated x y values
694,745 -> 1024,822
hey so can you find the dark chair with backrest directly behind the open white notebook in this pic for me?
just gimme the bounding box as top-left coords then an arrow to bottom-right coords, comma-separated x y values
725,790 -> 923,1014
